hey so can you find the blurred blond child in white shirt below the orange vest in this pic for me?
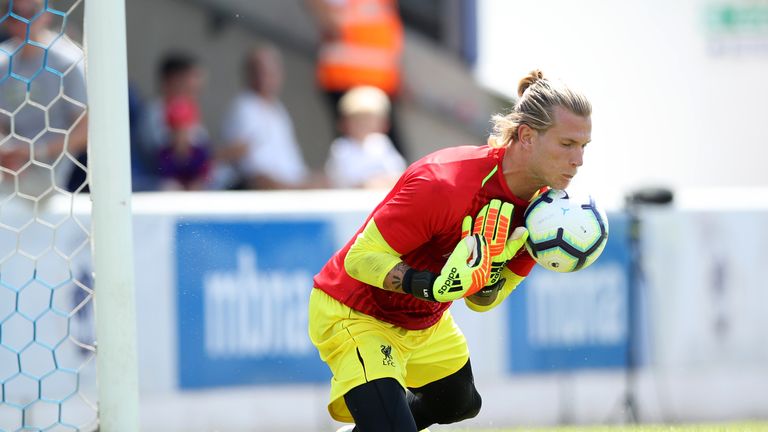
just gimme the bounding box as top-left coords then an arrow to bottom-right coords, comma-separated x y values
325,86 -> 406,189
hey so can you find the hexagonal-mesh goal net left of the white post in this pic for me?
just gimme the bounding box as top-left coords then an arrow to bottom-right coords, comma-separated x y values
0,0 -> 134,431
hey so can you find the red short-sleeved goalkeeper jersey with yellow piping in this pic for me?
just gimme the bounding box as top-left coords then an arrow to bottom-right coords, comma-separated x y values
314,146 -> 535,330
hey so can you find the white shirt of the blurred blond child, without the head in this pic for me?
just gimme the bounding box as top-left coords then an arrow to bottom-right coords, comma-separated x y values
325,133 -> 406,188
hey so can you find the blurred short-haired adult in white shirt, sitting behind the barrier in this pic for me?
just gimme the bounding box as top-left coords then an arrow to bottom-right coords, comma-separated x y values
217,45 -> 324,189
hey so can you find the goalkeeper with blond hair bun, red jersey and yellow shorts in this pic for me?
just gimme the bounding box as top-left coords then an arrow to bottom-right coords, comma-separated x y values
309,71 -> 591,432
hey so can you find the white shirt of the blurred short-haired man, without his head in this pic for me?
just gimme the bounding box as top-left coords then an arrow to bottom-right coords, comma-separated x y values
223,91 -> 309,185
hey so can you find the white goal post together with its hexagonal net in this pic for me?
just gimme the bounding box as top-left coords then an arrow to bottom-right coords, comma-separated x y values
0,0 -> 140,432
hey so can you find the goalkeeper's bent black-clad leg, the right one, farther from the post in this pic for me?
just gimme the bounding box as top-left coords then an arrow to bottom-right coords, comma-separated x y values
408,360 -> 482,430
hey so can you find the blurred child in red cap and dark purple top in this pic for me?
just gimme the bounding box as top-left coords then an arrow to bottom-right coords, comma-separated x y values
157,97 -> 211,190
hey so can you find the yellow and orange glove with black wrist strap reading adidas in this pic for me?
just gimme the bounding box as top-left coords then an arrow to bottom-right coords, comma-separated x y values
403,216 -> 491,302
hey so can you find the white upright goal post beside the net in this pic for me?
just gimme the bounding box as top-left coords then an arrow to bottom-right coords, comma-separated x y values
84,0 -> 139,432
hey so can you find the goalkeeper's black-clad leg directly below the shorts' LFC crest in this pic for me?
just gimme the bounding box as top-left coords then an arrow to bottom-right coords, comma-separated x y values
344,378 -> 417,432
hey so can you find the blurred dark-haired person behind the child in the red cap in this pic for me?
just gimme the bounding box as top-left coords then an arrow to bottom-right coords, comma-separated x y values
134,52 -> 210,180
